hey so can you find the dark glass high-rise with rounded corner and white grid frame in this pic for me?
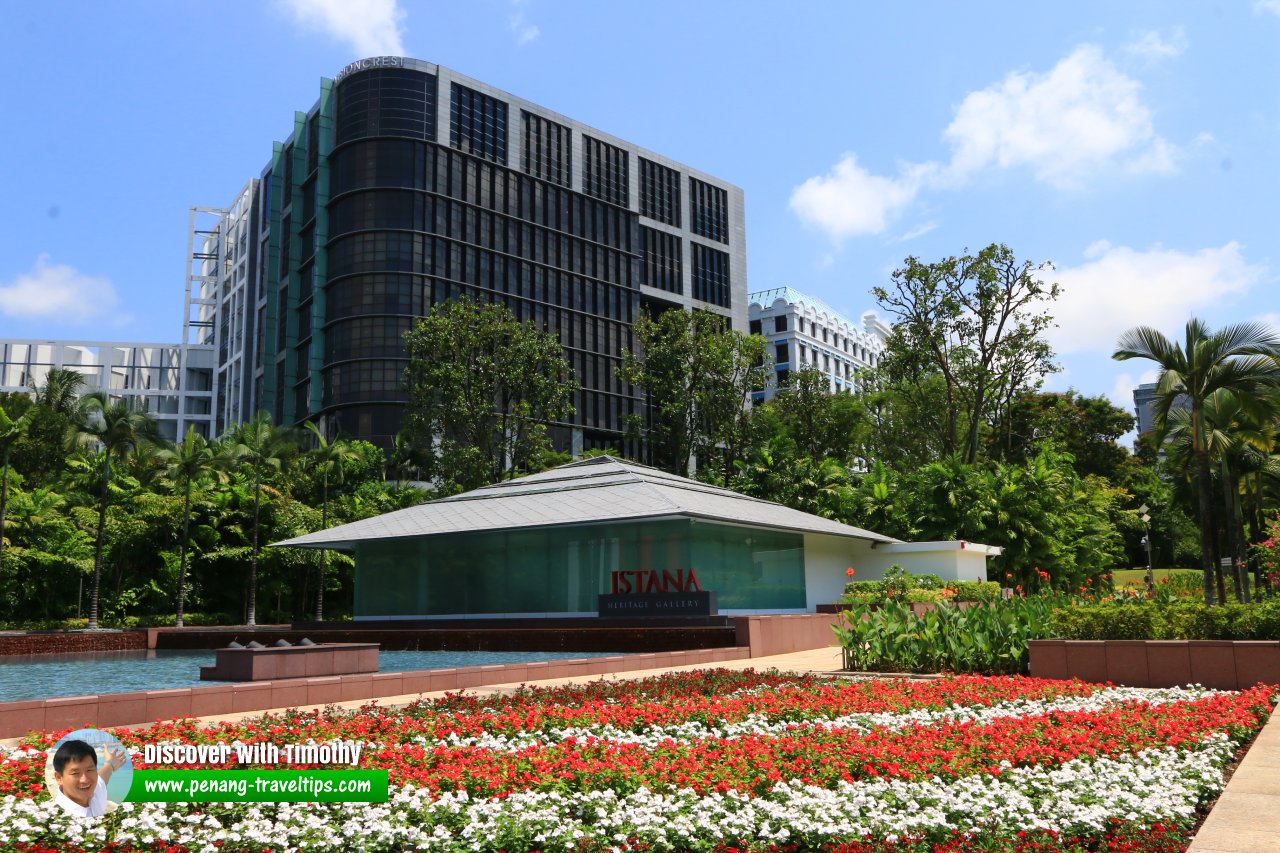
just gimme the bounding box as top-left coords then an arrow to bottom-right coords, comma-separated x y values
200,56 -> 748,453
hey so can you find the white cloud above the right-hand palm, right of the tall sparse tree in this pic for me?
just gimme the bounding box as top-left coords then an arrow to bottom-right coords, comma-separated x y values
1050,241 -> 1267,355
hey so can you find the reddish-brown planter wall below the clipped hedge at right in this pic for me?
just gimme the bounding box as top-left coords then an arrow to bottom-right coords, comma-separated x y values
1028,640 -> 1280,690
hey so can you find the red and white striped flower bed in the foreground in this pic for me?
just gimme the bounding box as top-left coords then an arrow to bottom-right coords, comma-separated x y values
0,671 -> 1272,853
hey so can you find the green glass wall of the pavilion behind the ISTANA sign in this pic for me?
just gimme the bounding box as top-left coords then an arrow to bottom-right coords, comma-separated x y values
356,519 -> 805,619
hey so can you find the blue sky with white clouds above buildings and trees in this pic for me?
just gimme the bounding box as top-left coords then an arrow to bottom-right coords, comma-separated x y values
0,0 -> 1280,417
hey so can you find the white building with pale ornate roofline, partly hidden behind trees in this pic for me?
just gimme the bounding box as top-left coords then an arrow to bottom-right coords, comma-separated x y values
748,287 -> 892,402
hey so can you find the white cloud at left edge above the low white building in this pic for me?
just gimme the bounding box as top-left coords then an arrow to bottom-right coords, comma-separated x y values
0,255 -> 119,323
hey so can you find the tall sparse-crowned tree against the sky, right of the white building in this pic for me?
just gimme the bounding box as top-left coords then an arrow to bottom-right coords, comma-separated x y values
872,243 -> 1059,465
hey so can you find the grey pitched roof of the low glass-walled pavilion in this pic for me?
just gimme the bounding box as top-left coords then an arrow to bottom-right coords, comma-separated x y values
274,456 -> 899,549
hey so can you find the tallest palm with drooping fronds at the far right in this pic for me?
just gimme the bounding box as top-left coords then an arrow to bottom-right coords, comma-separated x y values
1111,318 -> 1280,605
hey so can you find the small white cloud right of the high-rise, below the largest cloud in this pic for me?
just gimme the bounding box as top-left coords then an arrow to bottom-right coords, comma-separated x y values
791,154 -> 932,241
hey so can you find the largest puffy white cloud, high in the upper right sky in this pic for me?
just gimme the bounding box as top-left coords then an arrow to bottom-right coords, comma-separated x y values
945,45 -> 1172,187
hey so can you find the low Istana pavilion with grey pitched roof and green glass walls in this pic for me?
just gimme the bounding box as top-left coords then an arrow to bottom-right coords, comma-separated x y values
275,456 -> 1000,621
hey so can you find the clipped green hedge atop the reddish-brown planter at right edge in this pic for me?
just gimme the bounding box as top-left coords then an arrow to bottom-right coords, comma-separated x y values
1052,598 -> 1280,639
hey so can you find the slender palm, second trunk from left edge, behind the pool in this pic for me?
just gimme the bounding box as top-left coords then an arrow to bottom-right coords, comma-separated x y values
72,392 -> 156,630
